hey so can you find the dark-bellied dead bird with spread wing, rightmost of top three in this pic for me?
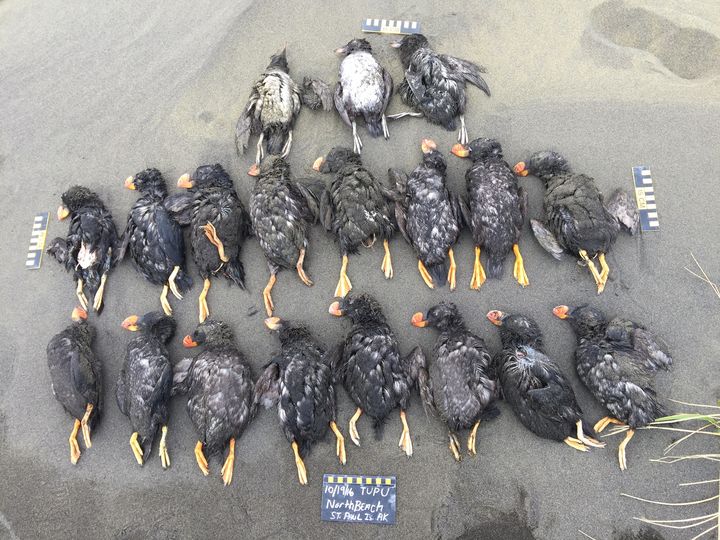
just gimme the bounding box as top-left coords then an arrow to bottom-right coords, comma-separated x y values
389,34 -> 490,144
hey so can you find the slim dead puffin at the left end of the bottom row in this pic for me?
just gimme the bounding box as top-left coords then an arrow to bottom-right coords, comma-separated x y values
47,307 -> 103,465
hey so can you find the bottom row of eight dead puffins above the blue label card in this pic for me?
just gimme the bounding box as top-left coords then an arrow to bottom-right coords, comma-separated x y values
47,295 -> 672,485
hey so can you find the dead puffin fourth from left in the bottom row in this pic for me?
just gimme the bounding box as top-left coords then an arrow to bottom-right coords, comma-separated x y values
254,317 -> 346,485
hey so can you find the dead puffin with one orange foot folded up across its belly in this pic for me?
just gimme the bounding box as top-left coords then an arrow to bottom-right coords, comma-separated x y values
165,163 -> 251,322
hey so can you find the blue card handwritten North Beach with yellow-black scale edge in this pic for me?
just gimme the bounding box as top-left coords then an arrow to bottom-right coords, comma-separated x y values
320,474 -> 397,525
